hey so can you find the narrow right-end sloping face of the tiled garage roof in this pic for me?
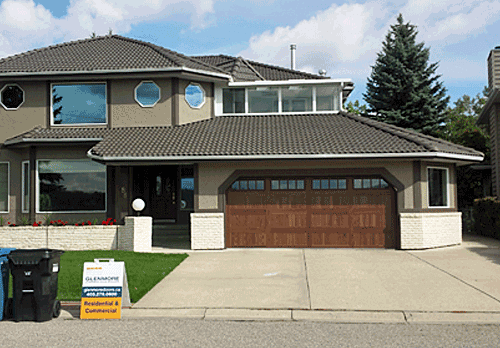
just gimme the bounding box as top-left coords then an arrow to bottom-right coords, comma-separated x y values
340,111 -> 481,153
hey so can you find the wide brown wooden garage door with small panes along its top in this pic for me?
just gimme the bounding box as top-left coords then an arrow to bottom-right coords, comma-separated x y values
226,177 -> 396,248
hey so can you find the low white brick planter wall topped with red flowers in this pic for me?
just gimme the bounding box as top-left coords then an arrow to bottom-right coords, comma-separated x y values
0,226 -> 118,250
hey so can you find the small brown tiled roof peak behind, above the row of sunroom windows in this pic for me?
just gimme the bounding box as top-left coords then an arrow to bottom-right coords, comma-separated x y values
192,54 -> 327,81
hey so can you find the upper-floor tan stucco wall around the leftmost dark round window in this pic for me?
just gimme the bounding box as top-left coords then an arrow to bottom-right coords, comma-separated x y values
0,81 -> 48,143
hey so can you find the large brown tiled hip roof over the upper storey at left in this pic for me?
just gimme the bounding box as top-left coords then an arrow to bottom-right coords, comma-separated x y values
0,35 -> 227,76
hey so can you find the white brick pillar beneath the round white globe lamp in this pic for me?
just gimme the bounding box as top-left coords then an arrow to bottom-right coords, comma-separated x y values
118,216 -> 153,252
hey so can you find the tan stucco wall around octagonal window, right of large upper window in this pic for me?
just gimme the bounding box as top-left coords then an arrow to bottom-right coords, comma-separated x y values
108,79 -> 172,127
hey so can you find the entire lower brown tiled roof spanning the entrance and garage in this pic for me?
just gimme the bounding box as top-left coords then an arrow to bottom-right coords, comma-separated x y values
5,112 -> 483,161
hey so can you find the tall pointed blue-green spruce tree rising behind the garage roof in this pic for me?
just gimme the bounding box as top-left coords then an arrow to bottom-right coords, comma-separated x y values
363,14 -> 449,135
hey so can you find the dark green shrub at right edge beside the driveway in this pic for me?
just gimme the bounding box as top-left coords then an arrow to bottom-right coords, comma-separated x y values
473,197 -> 500,239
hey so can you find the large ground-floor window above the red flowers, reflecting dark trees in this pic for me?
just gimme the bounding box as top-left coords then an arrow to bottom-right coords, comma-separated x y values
37,160 -> 106,212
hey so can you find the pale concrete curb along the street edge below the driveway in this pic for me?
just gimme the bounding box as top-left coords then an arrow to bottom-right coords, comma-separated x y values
60,303 -> 500,325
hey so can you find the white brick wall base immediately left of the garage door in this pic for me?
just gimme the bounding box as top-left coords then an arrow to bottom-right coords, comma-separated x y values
191,213 -> 225,250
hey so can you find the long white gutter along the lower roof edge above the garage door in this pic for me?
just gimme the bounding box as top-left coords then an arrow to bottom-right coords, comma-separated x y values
87,149 -> 484,162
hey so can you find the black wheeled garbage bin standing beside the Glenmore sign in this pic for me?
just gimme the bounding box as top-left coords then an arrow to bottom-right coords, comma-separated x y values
7,249 -> 64,321
